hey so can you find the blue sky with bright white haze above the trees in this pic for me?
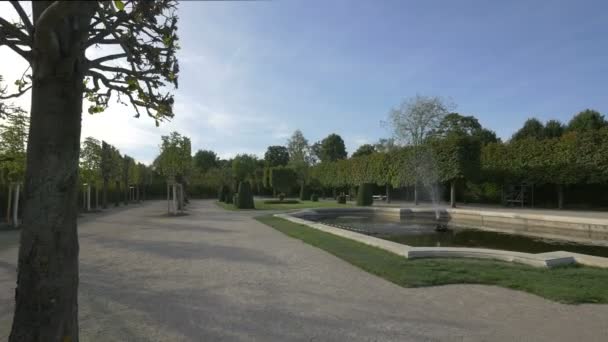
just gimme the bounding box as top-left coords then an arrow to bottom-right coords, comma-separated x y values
0,0 -> 608,163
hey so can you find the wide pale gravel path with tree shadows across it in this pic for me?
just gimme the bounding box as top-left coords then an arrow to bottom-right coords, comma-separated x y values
0,201 -> 608,342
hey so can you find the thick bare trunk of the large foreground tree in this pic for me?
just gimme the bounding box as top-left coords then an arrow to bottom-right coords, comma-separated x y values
9,1 -> 97,342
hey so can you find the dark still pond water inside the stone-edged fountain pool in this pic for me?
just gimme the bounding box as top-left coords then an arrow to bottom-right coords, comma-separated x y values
308,214 -> 608,257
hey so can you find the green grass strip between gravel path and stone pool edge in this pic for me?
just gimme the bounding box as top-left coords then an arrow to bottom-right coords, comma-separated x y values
256,215 -> 608,304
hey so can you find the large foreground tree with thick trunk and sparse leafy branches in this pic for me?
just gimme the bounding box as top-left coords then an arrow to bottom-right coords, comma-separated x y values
0,0 -> 178,342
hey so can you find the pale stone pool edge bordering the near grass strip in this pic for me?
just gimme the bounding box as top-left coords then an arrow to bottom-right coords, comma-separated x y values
274,210 -> 608,268
